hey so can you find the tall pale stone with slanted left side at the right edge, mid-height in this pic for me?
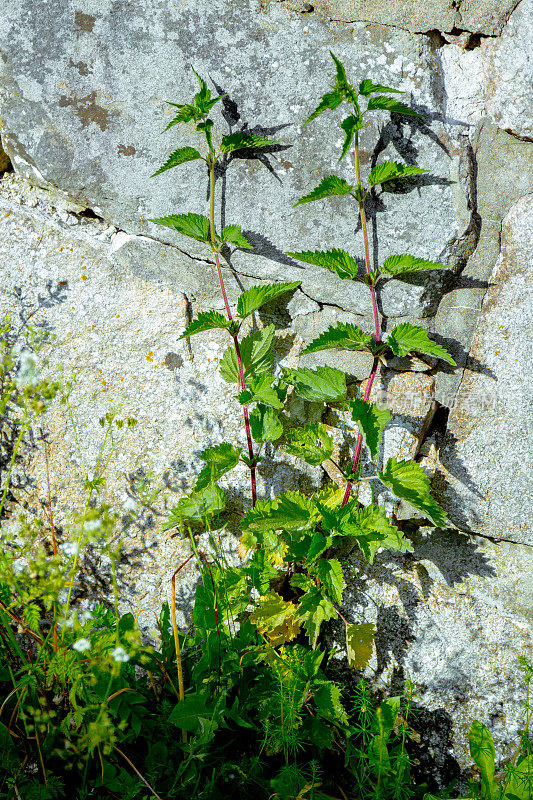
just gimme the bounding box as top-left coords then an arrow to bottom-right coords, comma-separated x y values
436,195 -> 533,544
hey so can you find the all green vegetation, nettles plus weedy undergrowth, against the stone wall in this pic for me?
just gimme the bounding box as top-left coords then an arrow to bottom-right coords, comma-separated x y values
0,56 -> 533,800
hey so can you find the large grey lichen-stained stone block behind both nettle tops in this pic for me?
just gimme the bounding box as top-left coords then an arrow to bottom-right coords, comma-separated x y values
0,0 -> 458,315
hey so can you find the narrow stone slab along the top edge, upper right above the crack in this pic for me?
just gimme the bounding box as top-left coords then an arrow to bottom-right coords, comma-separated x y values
308,0 -> 515,36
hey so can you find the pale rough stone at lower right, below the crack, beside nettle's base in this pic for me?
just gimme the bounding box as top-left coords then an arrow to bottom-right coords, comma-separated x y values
339,529 -> 533,769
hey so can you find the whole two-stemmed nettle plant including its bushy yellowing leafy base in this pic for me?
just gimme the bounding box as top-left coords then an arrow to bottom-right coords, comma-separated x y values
153,54 -> 455,668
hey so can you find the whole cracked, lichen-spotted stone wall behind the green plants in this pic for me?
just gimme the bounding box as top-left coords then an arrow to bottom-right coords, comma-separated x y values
0,0 -> 533,772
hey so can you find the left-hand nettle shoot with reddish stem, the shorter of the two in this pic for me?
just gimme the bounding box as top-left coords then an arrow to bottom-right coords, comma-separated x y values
151,70 -> 299,510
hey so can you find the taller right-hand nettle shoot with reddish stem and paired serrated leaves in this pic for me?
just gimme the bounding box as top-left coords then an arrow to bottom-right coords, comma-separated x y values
288,53 -> 455,506
